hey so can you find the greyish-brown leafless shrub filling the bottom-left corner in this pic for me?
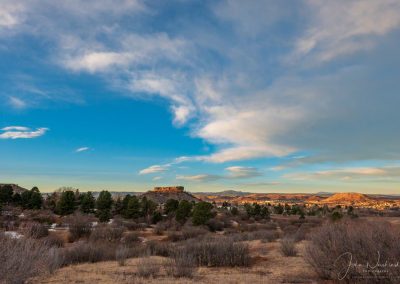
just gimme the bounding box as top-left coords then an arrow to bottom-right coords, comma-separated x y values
0,235 -> 60,284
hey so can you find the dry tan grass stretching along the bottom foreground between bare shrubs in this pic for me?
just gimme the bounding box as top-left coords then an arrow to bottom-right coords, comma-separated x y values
34,241 -> 317,284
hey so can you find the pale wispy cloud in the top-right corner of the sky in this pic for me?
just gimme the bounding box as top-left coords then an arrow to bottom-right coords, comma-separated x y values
295,0 -> 400,61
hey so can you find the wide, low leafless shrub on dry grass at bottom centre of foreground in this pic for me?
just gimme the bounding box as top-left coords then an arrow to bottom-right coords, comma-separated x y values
182,238 -> 250,267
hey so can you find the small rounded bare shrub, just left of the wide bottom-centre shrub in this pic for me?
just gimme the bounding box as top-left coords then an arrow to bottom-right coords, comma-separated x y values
164,249 -> 197,278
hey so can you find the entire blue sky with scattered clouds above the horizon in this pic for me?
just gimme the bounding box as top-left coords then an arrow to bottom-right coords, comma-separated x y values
0,0 -> 400,193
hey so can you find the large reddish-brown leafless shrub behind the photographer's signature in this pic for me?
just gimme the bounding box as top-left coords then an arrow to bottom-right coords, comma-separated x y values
305,220 -> 400,283
